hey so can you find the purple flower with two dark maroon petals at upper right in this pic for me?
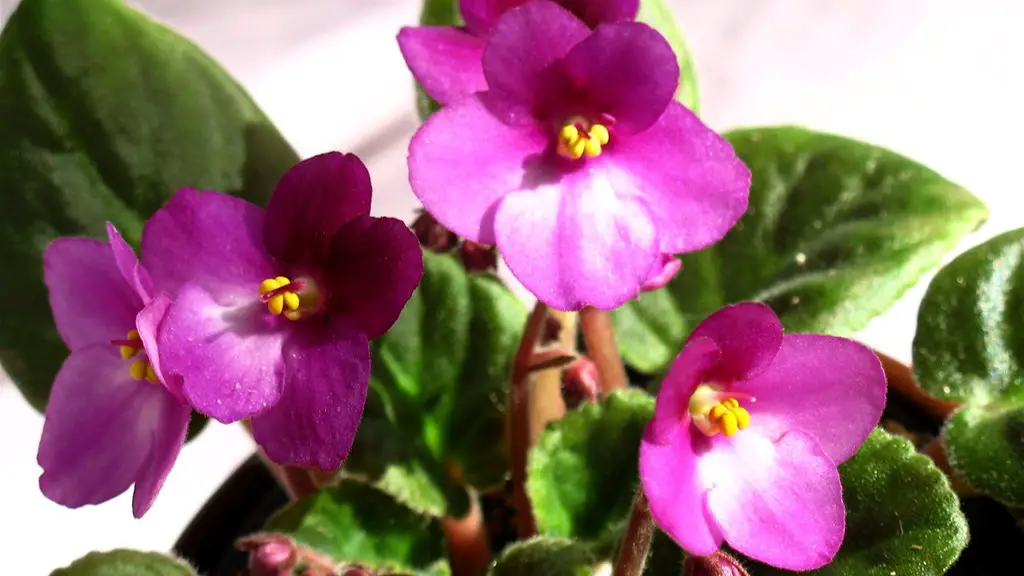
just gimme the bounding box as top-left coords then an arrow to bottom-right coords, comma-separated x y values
142,153 -> 423,469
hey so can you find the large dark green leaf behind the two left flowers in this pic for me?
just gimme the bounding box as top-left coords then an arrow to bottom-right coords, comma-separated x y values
0,0 -> 297,410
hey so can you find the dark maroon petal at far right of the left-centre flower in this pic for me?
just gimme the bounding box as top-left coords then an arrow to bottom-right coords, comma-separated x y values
324,216 -> 423,339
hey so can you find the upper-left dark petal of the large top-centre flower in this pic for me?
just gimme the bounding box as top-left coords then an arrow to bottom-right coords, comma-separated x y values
483,0 -> 590,113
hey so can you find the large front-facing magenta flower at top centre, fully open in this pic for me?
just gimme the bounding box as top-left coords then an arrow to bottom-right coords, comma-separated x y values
409,1 -> 751,310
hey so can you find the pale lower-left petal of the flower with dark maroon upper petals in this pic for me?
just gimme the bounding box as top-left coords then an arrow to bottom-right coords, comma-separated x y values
158,284 -> 291,423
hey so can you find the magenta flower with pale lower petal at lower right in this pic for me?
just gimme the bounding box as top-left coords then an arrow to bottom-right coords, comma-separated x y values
640,302 -> 886,570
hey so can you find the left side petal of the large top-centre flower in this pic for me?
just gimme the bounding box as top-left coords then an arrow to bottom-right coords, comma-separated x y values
409,96 -> 550,244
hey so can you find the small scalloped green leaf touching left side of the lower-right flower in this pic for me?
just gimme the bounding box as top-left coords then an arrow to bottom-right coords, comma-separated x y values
526,389 -> 654,553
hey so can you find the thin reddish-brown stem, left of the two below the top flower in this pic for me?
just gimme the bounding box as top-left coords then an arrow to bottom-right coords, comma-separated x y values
509,300 -> 548,538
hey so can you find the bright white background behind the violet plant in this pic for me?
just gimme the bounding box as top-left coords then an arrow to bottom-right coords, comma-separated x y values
0,0 -> 1024,576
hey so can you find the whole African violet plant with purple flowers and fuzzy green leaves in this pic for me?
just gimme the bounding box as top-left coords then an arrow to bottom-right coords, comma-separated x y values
0,0 -> 1024,576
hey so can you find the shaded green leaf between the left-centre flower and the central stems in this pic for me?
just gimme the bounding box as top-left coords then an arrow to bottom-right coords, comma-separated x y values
346,252 -> 526,517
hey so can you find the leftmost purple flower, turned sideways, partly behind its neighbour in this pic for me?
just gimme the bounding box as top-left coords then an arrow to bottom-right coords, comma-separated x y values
38,223 -> 191,518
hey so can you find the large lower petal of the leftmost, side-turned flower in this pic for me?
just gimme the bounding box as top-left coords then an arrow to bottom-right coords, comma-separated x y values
37,343 -> 170,508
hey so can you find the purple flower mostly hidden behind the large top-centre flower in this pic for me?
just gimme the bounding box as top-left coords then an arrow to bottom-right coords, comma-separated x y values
398,0 -> 640,105
